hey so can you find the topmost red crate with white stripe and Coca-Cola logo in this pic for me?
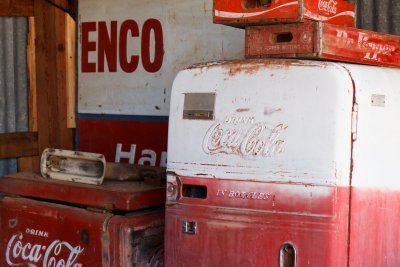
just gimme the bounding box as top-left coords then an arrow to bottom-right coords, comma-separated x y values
214,0 -> 355,27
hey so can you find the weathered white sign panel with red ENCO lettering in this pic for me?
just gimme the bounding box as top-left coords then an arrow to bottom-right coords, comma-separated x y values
77,0 -> 244,116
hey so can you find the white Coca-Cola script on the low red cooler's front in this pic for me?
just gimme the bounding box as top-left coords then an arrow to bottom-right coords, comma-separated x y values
6,233 -> 83,267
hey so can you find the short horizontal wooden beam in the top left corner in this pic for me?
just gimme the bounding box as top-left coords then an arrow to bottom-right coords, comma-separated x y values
0,0 -> 34,17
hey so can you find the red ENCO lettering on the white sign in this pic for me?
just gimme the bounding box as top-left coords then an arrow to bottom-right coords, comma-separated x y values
81,18 -> 164,73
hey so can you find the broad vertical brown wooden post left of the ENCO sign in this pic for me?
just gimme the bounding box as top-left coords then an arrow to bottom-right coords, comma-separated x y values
34,0 -> 74,154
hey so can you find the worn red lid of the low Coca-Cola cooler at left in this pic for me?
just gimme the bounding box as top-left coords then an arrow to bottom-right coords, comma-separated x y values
0,173 -> 165,211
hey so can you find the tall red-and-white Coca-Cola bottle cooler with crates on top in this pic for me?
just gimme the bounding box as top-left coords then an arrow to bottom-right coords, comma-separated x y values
165,59 -> 400,267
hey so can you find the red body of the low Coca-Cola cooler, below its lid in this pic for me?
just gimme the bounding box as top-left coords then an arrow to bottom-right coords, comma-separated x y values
0,197 -> 164,267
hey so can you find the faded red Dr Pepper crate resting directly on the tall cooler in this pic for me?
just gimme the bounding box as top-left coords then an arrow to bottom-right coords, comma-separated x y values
245,22 -> 400,67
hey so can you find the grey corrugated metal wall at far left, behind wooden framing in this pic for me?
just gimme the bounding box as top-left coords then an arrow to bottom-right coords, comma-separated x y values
0,17 -> 28,175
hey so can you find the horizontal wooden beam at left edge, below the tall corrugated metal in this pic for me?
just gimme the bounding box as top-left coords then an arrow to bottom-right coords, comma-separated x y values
0,132 -> 38,159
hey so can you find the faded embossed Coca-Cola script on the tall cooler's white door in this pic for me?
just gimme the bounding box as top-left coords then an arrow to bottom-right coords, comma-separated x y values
203,117 -> 288,157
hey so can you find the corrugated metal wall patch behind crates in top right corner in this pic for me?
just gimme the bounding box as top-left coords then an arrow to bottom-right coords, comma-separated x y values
350,0 -> 400,35
